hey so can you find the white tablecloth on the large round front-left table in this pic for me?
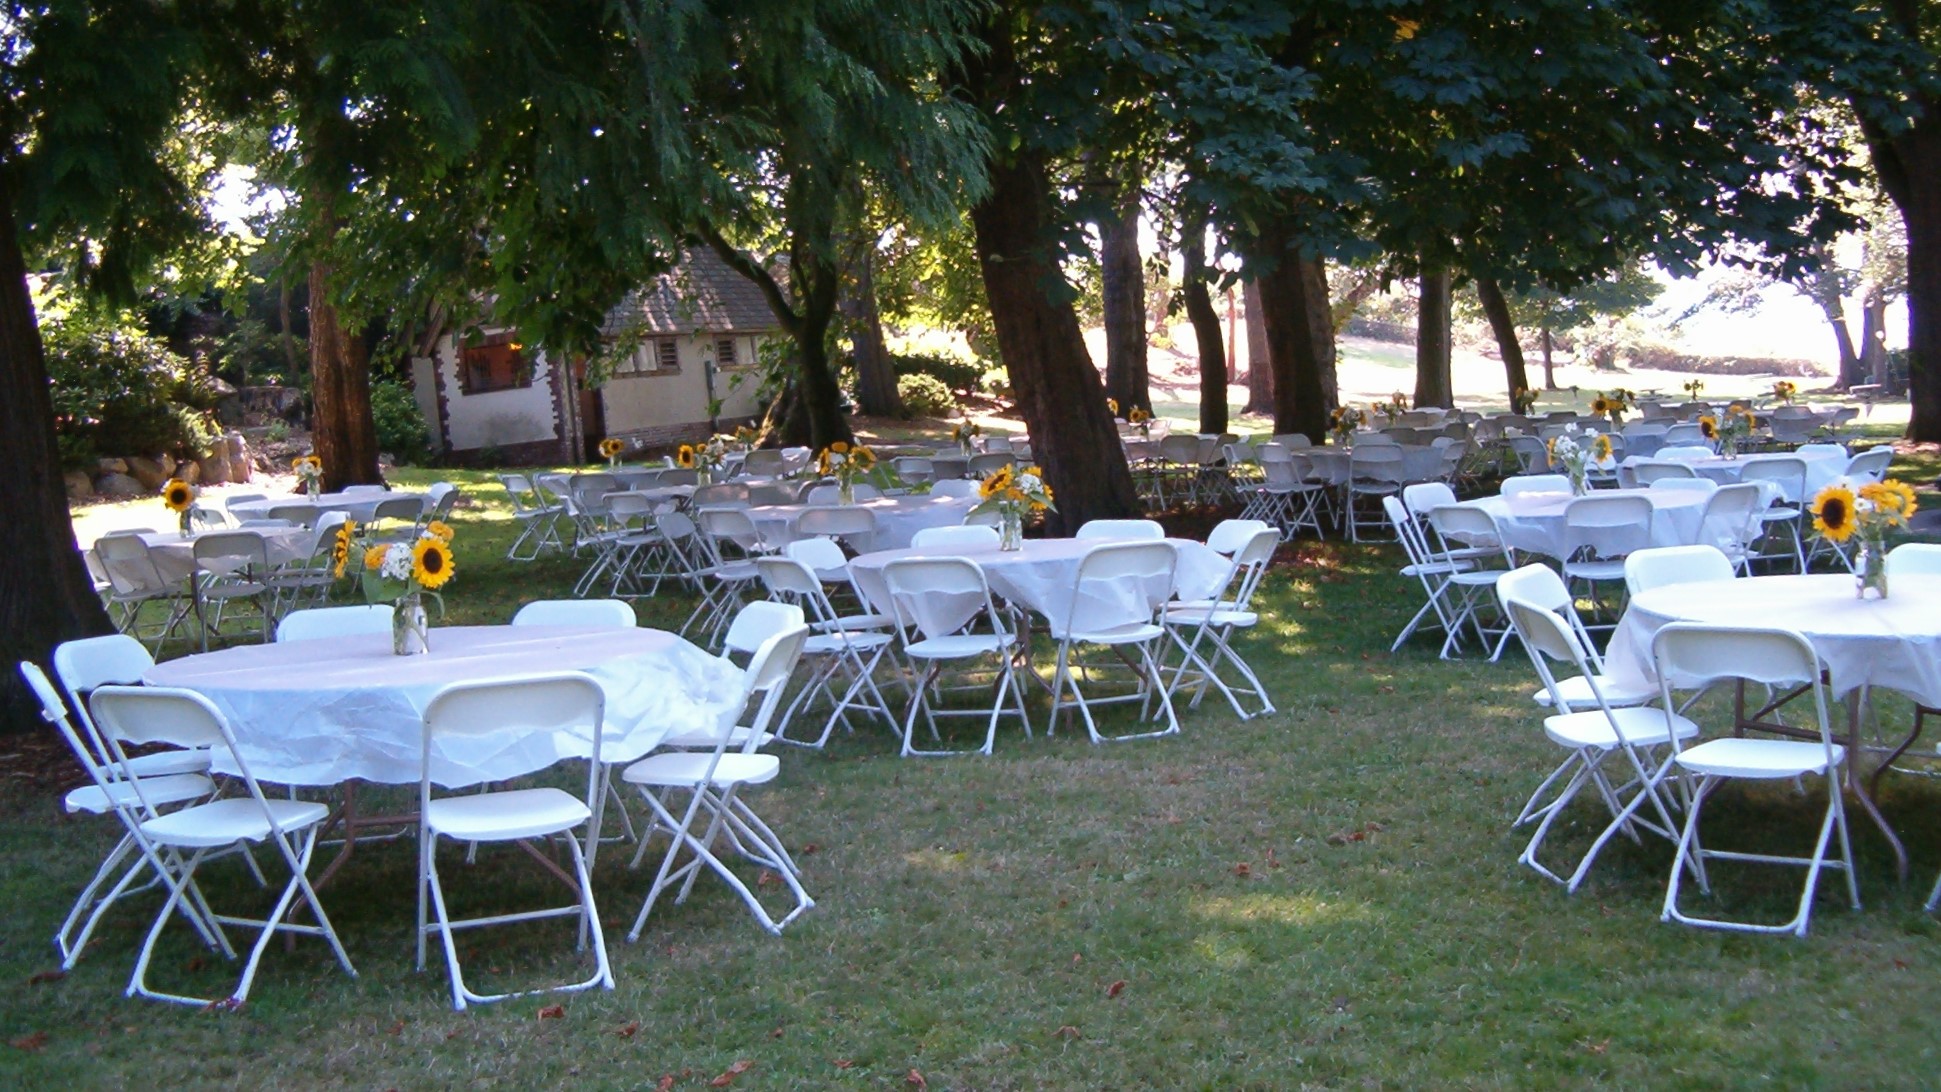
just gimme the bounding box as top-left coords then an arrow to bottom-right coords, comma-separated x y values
144,626 -> 741,787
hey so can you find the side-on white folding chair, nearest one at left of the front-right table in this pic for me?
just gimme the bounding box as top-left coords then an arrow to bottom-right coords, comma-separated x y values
1498,586 -> 1698,892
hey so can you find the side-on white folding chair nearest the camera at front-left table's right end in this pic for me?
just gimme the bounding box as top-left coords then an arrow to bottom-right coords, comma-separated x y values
621,626 -> 815,941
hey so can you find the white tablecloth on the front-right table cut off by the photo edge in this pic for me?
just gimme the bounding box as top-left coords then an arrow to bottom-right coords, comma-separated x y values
1603,574 -> 1941,706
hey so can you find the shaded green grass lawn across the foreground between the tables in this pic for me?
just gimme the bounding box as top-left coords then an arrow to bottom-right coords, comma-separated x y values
11,434 -> 1941,1088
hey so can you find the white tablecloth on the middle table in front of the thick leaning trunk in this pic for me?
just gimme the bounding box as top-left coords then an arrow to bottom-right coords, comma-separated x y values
850,539 -> 1231,628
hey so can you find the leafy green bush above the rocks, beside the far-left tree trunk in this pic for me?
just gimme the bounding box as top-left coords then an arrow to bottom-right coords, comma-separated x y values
43,312 -> 219,469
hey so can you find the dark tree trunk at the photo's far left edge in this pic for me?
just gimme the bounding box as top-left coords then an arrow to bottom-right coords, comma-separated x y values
0,183 -> 112,727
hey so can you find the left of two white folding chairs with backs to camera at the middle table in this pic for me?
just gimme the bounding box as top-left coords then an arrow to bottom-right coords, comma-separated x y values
883,557 -> 1031,756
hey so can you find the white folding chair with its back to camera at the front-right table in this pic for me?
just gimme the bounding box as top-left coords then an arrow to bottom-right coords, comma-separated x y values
1652,623 -> 1859,937
